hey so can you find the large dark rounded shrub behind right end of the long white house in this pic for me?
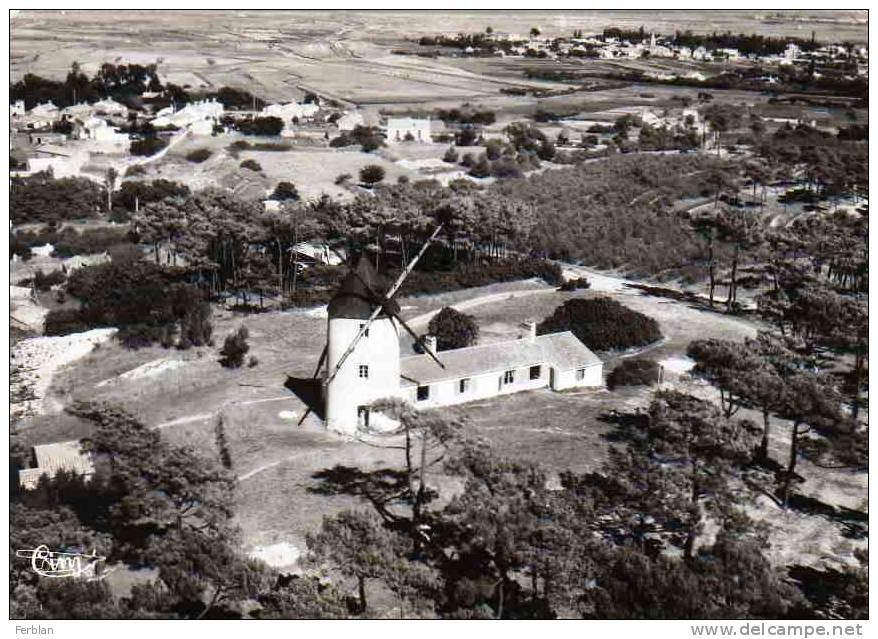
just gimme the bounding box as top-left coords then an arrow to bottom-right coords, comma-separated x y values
537,297 -> 662,351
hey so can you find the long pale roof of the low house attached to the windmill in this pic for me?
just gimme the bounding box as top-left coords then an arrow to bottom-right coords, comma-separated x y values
400,331 -> 601,386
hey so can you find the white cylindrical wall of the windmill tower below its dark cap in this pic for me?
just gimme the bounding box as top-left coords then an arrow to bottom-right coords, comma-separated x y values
326,318 -> 399,435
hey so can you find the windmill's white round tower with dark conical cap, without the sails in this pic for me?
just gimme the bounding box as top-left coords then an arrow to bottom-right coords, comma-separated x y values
324,257 -> 400,435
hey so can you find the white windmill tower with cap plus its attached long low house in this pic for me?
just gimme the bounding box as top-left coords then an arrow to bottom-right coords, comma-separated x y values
324,257 -> 603,435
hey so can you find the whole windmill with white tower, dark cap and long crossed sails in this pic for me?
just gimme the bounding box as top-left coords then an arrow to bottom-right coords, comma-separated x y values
299,224 -> 445,430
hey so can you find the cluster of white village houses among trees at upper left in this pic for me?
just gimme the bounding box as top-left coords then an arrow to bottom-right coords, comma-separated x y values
10,92 -> 442,178
